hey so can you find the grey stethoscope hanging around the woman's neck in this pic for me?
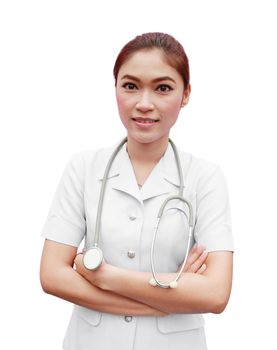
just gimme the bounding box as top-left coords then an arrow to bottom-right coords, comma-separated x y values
83,138 -> 193,288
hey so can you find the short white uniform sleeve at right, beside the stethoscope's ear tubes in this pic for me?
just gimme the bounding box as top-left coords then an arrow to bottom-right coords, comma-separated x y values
194,166 -> 234,251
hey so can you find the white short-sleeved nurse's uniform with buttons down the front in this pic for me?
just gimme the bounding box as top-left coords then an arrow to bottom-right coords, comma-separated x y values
42,141 -> 233,350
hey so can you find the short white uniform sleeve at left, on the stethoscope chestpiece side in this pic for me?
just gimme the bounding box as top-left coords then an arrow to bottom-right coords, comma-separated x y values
42,154 -> 86,247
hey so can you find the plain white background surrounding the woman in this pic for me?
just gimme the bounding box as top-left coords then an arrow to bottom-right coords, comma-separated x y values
0,0 -> 277,350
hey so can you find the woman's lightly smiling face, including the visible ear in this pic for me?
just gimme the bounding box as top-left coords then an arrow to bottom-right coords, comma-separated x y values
116,49 -> 190,143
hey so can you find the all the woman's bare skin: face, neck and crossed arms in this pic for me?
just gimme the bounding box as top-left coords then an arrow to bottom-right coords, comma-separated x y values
40,49 -> 233,316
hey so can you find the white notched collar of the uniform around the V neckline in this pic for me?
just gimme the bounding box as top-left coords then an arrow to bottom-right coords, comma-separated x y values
97,144 -> 185,203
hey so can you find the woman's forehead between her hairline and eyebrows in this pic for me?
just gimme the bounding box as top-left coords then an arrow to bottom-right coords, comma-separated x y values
118,49 -> 182,80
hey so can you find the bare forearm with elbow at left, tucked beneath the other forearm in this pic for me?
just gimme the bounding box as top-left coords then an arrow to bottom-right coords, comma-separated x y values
41,266 -> 164,316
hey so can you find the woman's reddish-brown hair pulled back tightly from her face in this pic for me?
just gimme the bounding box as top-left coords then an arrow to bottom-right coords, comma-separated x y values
113,32 -> 190,90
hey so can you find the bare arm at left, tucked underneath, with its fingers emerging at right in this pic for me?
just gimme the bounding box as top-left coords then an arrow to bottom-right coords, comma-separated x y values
40,239 -> 207,316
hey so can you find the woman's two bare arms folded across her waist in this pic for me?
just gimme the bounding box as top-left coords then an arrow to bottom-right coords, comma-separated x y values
40,240 -> 232,316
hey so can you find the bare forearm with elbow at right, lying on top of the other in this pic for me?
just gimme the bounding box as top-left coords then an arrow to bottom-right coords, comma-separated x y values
96,253 -> 232,313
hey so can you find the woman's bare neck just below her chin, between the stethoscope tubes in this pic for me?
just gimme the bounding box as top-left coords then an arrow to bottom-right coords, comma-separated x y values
127,137 -> 168,163
